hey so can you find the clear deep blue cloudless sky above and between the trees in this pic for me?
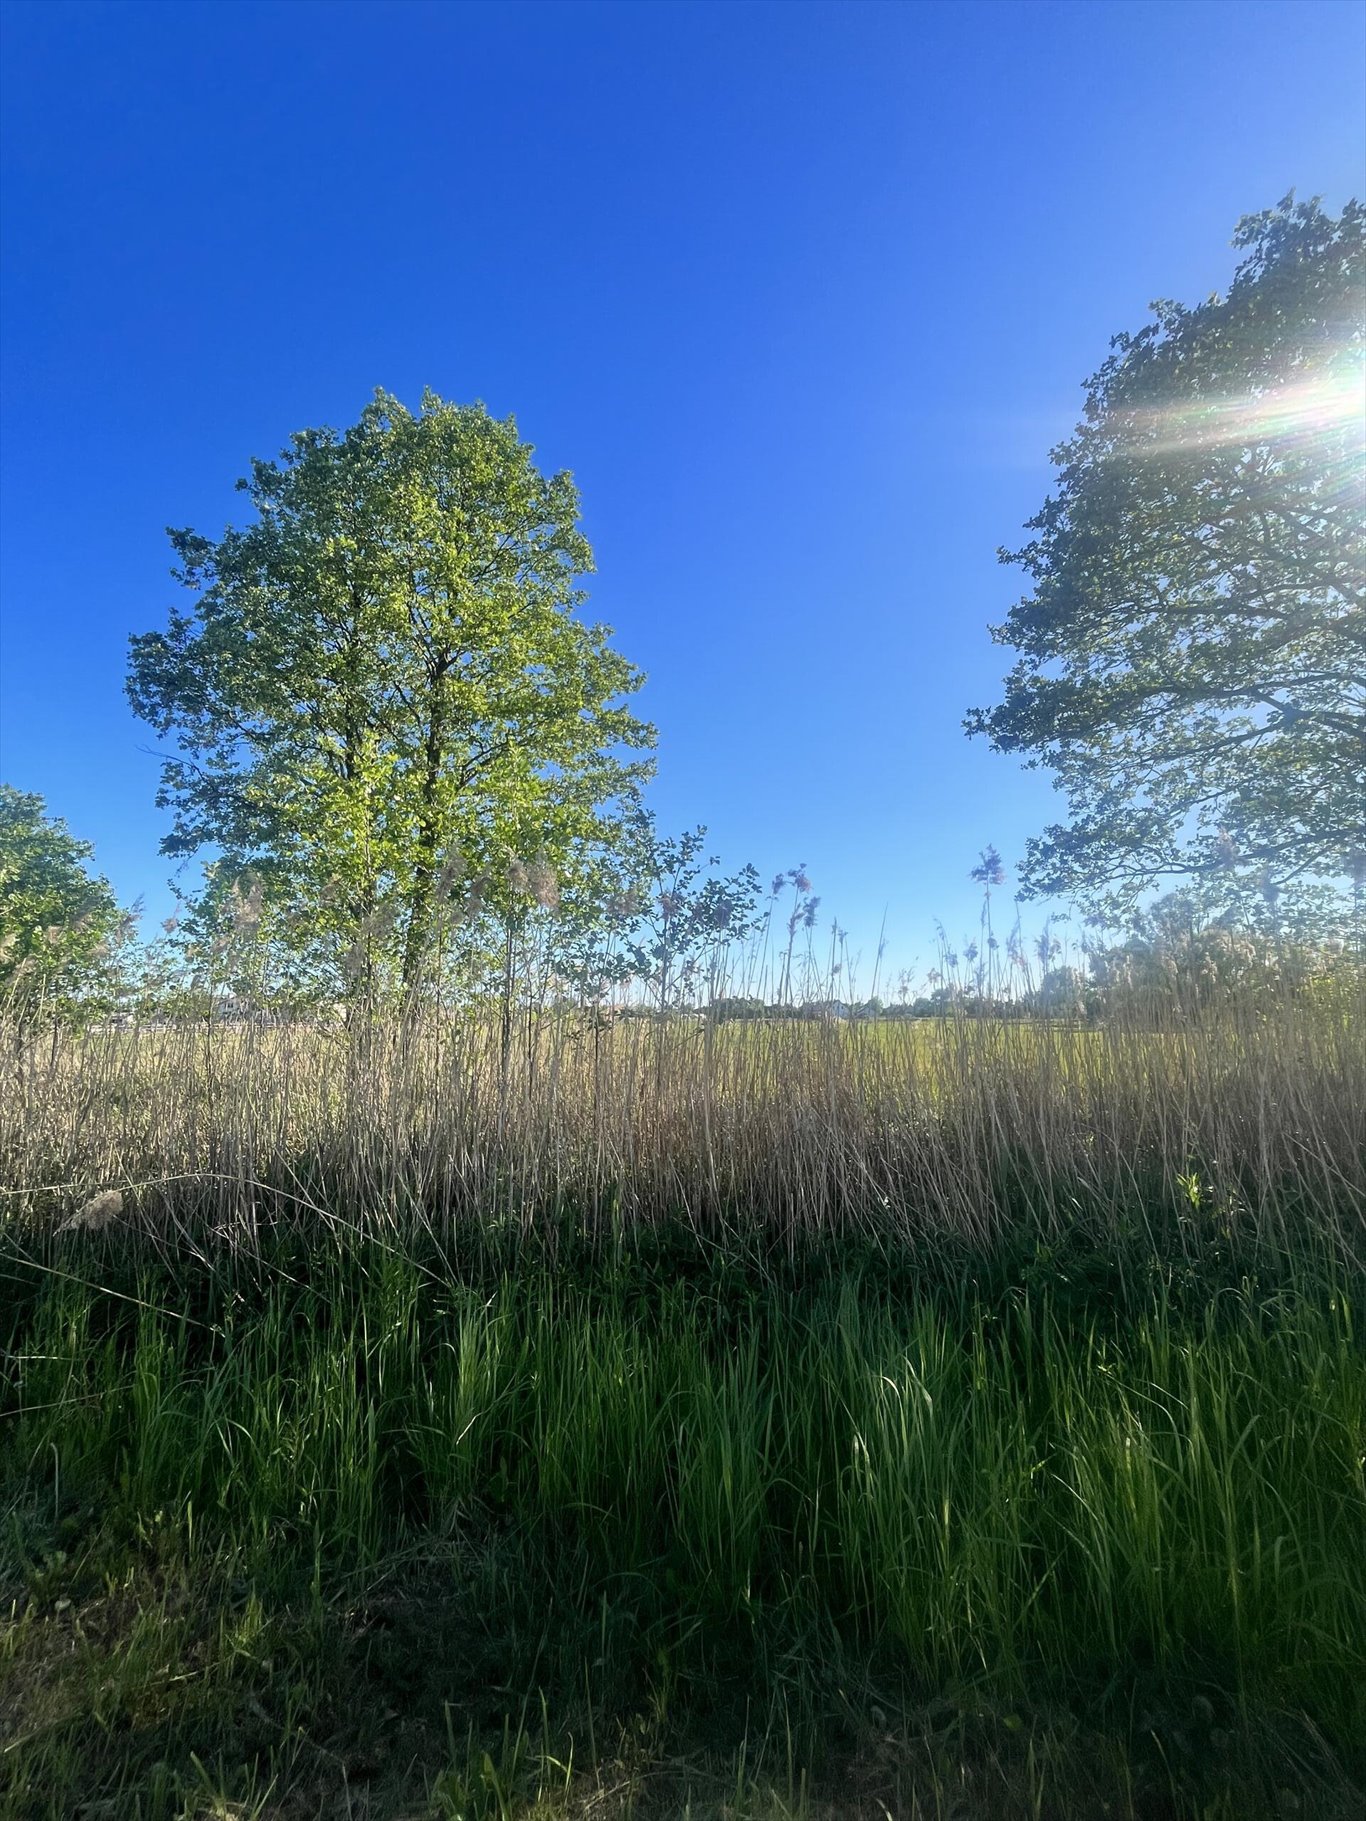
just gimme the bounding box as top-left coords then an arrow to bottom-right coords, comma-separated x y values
0,0 -> 1366,972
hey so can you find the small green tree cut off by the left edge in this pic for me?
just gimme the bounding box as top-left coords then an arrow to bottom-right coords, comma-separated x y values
0,785 -> 129,1014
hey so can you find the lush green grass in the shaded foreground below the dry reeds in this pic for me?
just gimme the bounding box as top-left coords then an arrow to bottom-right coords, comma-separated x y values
0,1235 -> 1366,1816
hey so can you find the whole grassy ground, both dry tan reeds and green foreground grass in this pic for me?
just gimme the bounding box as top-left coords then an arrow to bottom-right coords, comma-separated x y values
0,996 -> 1366,1821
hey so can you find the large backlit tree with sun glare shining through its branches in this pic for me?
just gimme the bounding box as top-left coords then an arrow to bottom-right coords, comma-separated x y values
967,197 -> 1366,901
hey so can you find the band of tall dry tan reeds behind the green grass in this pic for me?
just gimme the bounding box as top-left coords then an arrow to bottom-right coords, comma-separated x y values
0,996 -> 1366,1258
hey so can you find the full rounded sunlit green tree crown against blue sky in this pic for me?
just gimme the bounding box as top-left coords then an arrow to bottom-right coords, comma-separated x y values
127,392 -> 652,992
